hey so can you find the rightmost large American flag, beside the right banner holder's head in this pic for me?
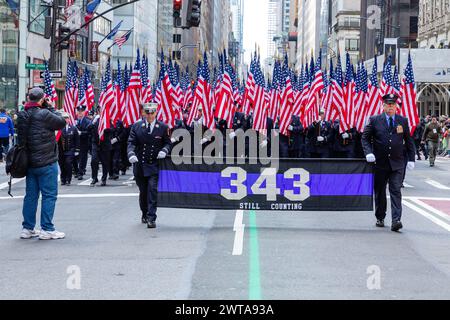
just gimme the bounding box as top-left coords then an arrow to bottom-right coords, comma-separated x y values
400,53 -> 419,135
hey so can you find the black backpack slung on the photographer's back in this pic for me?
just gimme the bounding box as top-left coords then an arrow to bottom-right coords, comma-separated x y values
5,111 -> 30,197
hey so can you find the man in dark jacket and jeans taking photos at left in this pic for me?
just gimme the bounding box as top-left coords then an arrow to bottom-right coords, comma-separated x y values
17,88 -> 66,240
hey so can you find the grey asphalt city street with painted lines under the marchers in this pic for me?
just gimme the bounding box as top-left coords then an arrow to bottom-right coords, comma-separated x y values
0,158 -> 450,300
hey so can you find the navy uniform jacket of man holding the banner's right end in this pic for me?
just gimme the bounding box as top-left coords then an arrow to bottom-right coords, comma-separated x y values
362,113 -> 415,171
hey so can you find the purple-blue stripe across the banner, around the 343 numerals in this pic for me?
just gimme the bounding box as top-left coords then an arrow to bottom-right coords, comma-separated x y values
158,170 -> 373,197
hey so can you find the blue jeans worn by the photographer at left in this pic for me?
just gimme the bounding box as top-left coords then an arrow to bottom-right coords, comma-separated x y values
22,162 -> 58,231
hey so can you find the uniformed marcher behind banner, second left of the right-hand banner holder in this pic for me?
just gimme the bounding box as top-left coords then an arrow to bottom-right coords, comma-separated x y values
307,111 -> 333,159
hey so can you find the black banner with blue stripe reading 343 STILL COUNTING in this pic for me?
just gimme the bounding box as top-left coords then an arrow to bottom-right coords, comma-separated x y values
158,159 -> 373,211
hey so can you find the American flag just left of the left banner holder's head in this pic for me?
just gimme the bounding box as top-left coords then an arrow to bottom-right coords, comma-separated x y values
126,49 -> 142,126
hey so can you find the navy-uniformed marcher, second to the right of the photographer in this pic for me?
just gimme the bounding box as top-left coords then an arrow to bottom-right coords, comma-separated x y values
76,106 -> 92,181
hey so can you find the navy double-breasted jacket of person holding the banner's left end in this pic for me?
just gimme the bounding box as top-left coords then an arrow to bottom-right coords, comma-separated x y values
128,120 -> 171,177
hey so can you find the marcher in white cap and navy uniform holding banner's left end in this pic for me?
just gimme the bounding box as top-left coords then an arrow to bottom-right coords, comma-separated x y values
128,103 -> 171,229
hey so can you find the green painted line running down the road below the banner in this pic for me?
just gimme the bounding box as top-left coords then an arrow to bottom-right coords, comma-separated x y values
248,211 -> 262,300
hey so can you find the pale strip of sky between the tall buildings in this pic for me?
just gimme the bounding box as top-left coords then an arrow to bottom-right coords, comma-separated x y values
243,0 -> 268,64
